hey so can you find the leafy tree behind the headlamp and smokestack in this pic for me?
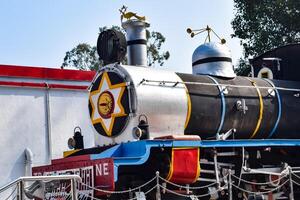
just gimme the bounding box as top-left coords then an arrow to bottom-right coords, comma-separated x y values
62,26 -> 170,70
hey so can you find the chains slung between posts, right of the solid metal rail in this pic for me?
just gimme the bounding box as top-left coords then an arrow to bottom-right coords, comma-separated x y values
74,168 -> 300,200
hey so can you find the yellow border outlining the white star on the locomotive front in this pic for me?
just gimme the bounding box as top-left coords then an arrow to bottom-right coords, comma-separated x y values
89,72 -> 127,137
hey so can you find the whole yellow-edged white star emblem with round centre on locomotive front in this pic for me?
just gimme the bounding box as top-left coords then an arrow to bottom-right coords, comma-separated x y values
89,72 -> 127,136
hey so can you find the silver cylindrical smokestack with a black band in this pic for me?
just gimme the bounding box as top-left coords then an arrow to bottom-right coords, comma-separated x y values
122,20 -> 150,66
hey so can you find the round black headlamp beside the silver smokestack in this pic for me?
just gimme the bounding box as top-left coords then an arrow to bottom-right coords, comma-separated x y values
97,29 -> 127,65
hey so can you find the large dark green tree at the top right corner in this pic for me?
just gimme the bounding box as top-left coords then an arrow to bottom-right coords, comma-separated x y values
231,0 -> 300,76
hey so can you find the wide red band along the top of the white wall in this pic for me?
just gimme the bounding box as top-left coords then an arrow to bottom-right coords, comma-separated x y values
0,65 -> 96,81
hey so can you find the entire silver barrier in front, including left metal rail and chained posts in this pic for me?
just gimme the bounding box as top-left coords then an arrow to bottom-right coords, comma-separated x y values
4,167 -> 300,200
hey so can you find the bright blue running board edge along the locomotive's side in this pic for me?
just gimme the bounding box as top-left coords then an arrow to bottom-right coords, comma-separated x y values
91,139 -> 300,162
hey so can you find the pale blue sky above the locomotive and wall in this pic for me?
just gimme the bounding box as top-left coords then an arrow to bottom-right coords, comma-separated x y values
0,0 -> 242,73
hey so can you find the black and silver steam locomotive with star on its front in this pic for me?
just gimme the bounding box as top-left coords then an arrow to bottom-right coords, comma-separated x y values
33,17 -> 300,199
